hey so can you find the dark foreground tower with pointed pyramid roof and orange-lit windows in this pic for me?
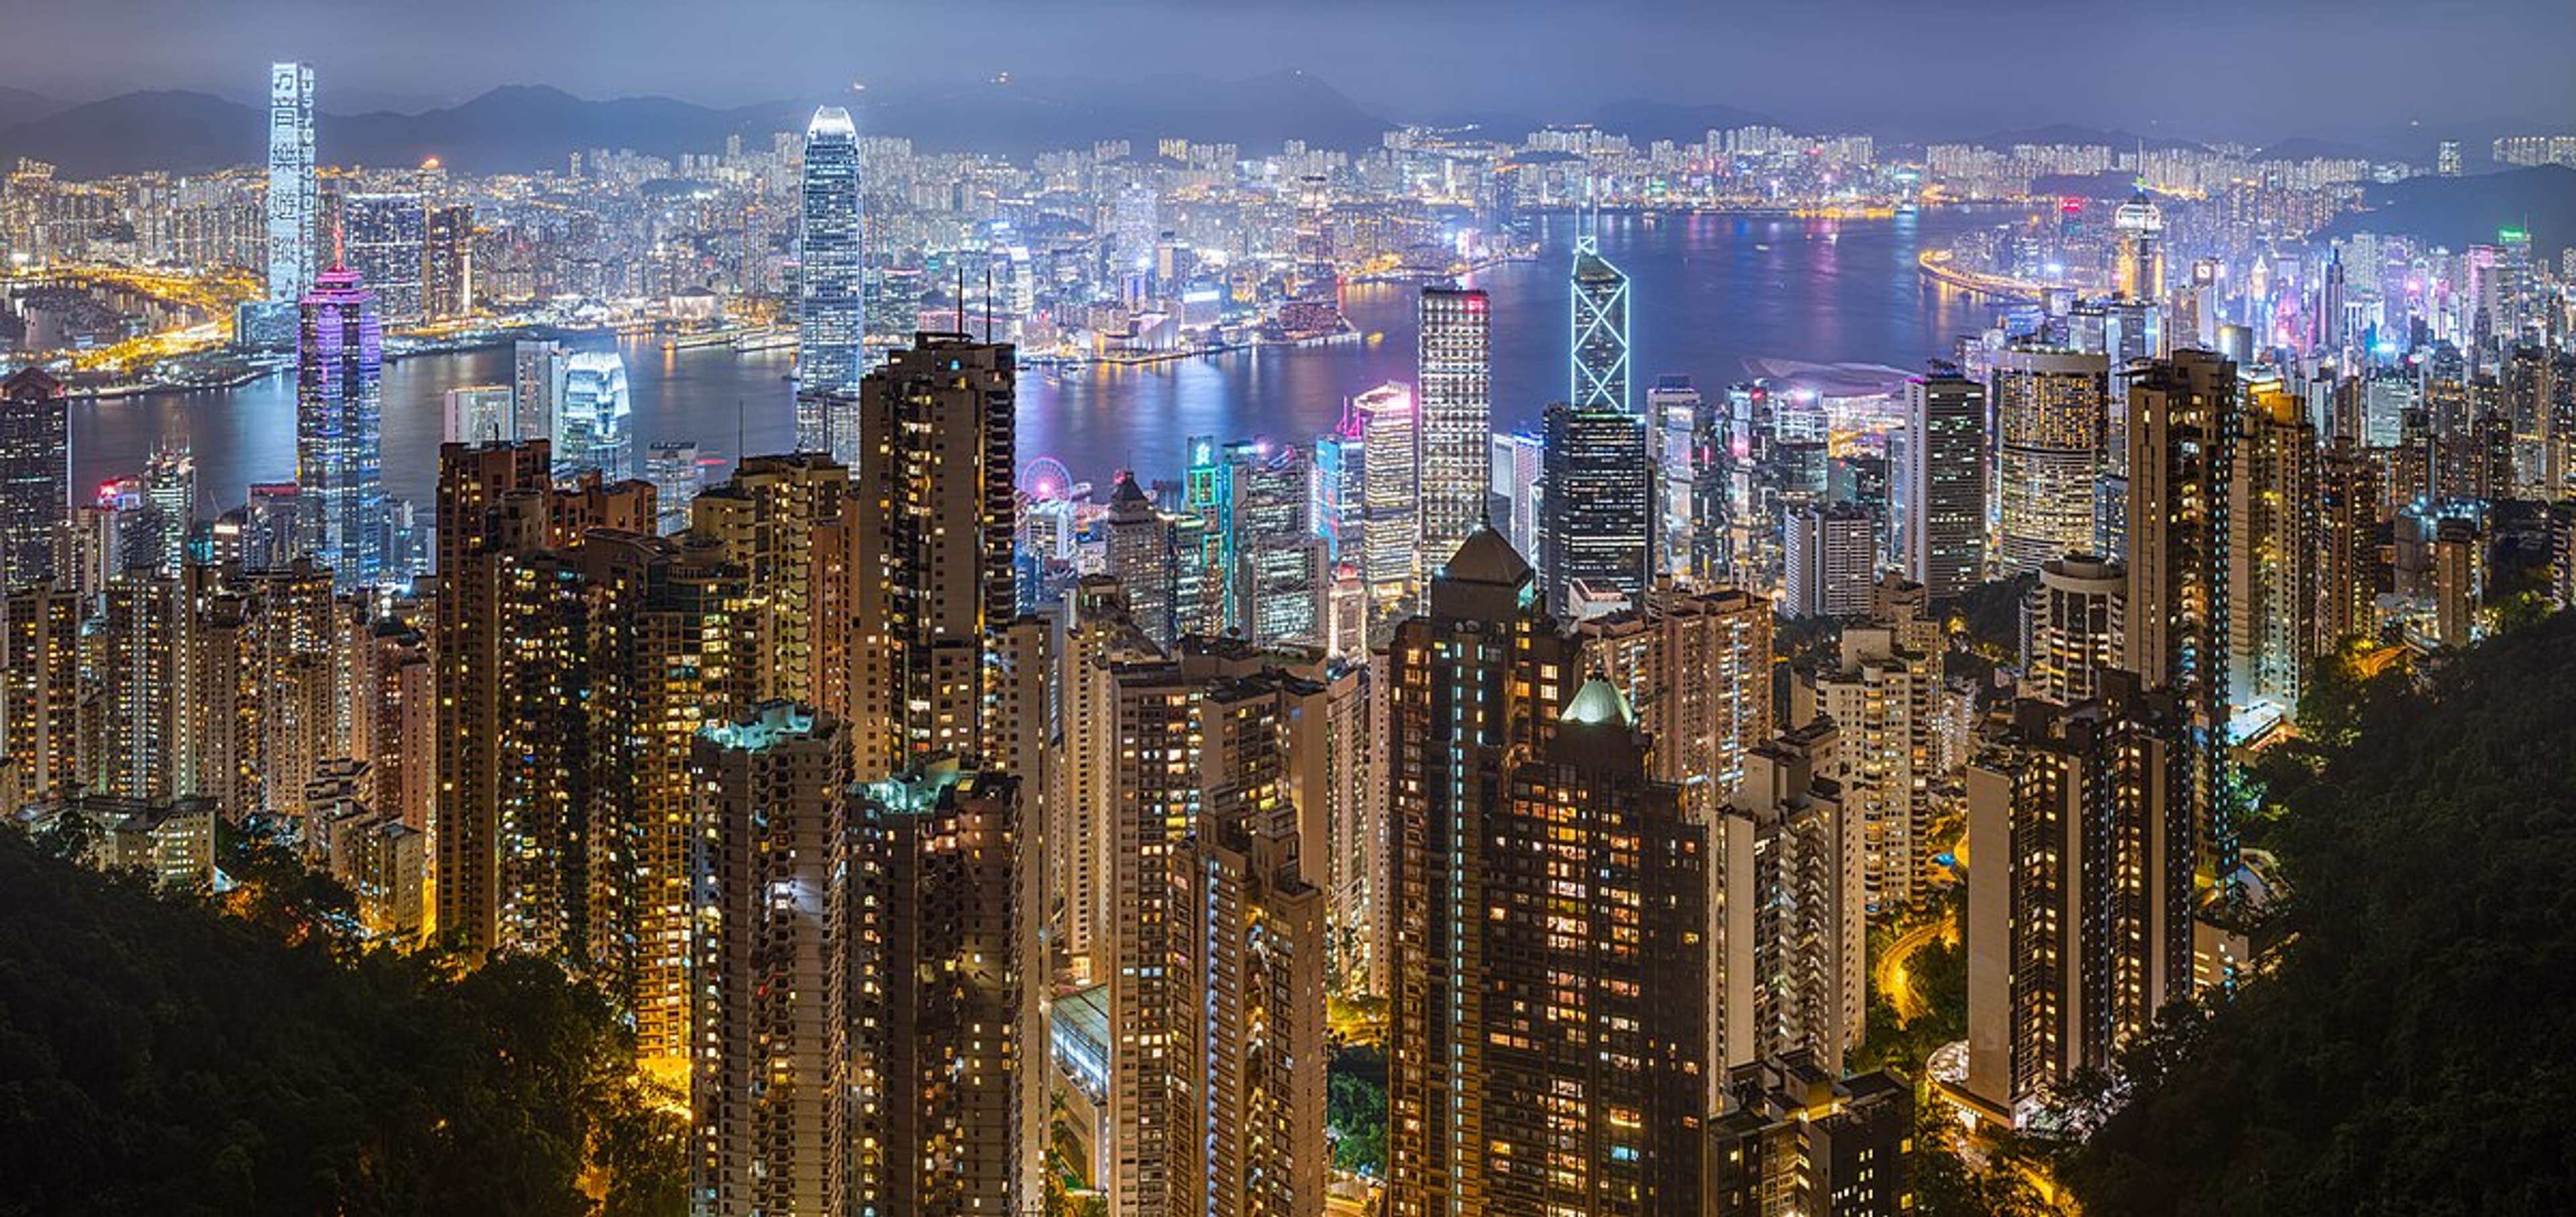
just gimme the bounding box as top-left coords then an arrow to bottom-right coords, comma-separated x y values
1383,529 -> 1579,1217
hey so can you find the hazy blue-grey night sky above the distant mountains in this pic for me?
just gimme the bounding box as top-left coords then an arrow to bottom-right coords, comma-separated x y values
20,0 -> 2576,140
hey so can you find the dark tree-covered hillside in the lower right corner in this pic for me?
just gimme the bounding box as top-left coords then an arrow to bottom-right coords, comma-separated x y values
2061,614 -> 2576,1217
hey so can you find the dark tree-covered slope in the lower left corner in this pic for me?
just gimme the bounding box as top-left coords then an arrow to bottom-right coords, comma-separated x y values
0,831 -> 685,1217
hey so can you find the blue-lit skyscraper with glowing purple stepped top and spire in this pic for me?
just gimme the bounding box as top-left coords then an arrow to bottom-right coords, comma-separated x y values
297,266 -> 384,590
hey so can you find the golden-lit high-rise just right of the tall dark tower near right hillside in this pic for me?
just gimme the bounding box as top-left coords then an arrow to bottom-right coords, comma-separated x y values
2226,382 -> 2318,722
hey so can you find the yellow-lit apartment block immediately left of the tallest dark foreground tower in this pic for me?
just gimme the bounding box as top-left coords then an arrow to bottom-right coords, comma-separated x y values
685,454 -> 850,704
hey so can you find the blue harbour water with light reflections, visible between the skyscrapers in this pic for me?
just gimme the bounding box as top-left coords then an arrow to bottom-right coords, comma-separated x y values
55,211 -> 1994,511
